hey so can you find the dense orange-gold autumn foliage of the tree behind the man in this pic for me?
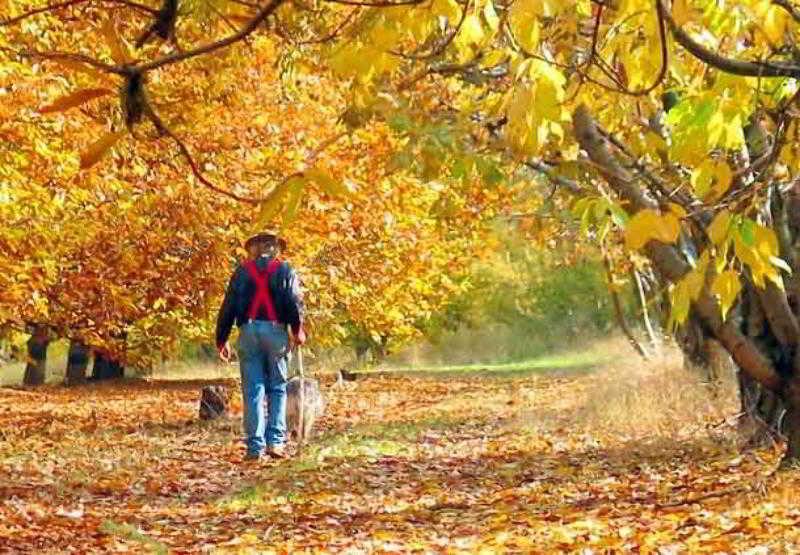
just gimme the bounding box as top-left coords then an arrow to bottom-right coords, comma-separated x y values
0,0 -> 506,356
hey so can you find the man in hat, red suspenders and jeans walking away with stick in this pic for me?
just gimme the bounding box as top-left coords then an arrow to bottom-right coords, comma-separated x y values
217,233 -> 306,460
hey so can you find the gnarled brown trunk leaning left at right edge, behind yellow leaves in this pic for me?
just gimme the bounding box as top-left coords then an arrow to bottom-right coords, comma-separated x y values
573,106 -> 800,464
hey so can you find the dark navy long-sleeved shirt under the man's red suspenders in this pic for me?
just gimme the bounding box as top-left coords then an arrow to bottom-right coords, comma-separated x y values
217,256 -> 303,347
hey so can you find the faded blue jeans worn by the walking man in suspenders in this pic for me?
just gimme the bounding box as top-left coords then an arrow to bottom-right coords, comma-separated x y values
238,321 -> 289,454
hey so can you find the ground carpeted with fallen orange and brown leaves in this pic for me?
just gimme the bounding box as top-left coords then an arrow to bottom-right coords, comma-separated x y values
0,352 -> 800,553
